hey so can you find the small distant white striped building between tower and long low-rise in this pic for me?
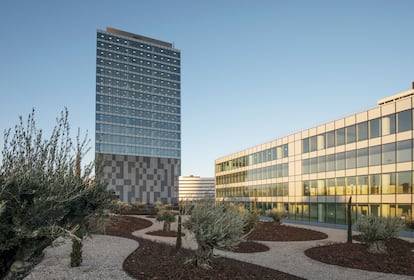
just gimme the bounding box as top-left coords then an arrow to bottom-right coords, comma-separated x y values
178,175 -> 215,201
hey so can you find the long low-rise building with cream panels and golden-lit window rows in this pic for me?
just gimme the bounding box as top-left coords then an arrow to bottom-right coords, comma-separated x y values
215,86 -> 414,224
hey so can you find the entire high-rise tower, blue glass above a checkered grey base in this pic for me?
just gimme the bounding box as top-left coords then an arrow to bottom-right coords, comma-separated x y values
95,28 -> 181,203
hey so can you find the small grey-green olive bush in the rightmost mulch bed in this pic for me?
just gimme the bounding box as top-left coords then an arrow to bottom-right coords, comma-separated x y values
357,216 -> 404,253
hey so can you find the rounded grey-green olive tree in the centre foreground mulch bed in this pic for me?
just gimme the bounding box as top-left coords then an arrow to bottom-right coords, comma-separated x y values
183,199 -> 246,269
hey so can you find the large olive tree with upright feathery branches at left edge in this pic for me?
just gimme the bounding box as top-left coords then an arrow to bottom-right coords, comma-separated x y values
0,109 -> 113,279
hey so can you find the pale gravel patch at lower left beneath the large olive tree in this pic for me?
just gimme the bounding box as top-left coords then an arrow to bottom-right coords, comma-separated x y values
24,235 -> 138,280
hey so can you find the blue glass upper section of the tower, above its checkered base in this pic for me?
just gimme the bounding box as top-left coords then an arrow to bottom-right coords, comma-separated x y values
95,31 -> 181,159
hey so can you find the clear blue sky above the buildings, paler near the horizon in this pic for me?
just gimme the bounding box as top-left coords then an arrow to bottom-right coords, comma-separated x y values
0,0 -> 414,176
